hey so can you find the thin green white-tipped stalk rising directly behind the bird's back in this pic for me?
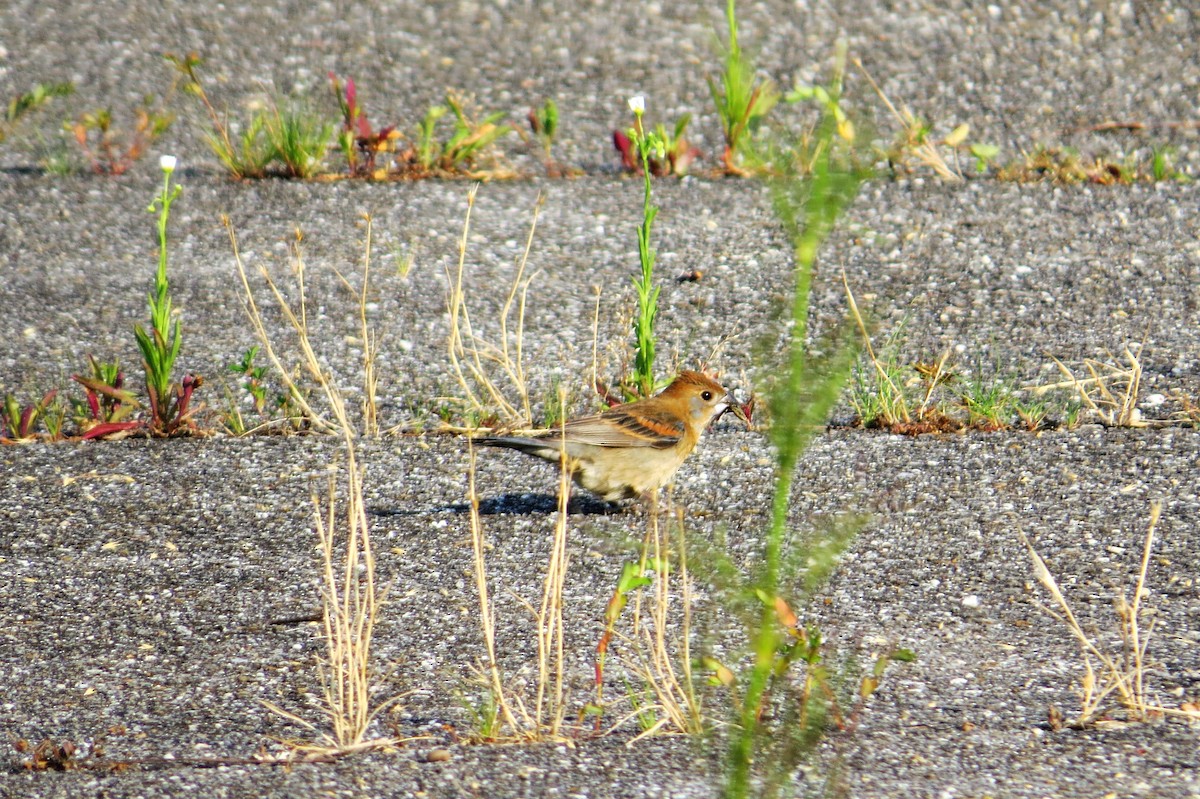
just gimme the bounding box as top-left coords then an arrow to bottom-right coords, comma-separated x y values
629,96 -> 665,397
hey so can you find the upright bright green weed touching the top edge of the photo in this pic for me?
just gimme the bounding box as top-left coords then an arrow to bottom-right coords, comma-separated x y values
708,0 -> 780,175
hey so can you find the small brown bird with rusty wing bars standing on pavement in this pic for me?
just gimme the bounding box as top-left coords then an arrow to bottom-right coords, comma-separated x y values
476,370 -> 739,503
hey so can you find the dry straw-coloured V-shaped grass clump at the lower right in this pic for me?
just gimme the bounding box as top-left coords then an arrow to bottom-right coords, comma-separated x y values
1018,501 -> 1171,726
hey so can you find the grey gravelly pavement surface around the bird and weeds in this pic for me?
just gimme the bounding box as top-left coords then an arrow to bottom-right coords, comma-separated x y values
0,0 -> 1200,799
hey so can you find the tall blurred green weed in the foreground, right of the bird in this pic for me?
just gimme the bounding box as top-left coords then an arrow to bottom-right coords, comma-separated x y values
710,52 -> 894,798
